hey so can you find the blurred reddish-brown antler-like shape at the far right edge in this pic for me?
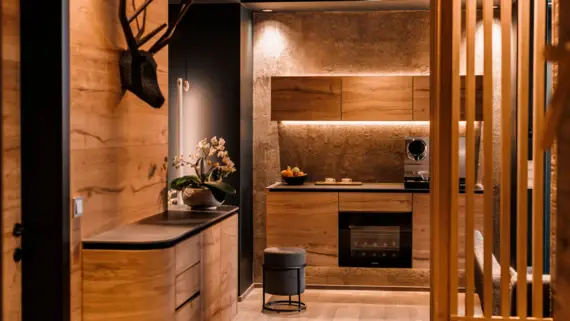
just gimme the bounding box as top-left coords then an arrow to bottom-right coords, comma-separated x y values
542,42 -> 570,150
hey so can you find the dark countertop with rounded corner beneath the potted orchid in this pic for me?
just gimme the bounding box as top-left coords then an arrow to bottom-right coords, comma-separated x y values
83,205 -> 239,250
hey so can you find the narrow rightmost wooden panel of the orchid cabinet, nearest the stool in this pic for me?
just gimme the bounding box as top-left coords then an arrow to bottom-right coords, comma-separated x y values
220,215 -> 235,321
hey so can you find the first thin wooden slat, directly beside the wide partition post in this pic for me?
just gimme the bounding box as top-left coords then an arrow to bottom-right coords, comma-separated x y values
449,1 -> 461,314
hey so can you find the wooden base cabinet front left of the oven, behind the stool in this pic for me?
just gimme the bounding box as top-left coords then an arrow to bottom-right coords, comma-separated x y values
266,192 -> 338,266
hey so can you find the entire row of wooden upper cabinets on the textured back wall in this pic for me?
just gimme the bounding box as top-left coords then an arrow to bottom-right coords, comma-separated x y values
271,76 -> 483,121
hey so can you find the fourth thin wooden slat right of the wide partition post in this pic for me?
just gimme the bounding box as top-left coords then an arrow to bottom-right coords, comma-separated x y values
500,0 -> 513,317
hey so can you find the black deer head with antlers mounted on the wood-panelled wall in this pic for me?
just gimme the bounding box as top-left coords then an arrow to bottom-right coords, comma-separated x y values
119,0 -> 193,108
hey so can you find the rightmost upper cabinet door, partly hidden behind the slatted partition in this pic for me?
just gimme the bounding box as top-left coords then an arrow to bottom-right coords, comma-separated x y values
413,76 -> 483,121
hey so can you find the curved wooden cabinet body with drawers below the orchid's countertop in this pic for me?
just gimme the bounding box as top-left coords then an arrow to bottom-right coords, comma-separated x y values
83,215 -> 238,321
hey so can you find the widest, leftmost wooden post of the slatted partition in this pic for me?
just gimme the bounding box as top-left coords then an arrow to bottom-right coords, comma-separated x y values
430,0 -> 450,321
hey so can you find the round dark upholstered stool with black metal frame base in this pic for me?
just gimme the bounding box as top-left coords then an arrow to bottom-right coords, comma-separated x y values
263,247 -> 307,312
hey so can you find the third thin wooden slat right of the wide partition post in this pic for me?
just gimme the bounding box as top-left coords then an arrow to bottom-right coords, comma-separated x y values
483,0 -> 493,317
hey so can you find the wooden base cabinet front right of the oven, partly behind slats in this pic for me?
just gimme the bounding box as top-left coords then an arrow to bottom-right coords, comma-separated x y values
412,194 -> 484,269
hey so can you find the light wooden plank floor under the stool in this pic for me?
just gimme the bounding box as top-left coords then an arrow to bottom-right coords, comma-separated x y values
235,289 -> 482,321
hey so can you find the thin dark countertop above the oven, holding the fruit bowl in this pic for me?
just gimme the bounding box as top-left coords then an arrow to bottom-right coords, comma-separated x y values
265,182 -> 483,194
